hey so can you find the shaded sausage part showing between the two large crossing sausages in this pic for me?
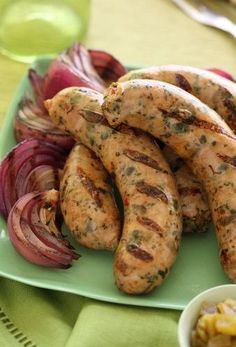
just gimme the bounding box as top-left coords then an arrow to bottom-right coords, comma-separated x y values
162,146 -> 211,233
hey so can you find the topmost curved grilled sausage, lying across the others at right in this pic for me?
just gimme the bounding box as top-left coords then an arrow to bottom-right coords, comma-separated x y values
102,79 -> 236,281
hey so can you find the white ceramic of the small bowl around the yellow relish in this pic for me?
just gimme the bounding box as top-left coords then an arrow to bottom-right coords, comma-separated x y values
178,284 -> 236,347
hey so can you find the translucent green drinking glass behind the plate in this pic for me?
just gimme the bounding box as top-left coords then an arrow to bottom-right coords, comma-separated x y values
0,0 -> 90,62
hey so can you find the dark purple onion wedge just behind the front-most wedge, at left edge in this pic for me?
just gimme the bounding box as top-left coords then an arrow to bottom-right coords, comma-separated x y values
0,139 -> 67,218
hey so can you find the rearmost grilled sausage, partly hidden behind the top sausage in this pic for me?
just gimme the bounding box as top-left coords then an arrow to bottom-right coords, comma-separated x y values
119,65 -> 236,132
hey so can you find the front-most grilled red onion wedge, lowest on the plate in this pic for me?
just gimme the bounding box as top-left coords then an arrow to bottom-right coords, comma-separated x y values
7,189 -> 79,268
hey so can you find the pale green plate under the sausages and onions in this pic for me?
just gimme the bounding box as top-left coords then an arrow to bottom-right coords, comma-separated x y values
0,58 -> 229,310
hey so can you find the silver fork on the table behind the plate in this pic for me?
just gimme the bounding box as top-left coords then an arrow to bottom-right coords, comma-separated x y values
172,0 -> 236,38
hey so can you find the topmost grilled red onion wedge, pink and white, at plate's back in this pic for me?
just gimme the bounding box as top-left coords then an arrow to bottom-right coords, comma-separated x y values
29,43 -> 127,104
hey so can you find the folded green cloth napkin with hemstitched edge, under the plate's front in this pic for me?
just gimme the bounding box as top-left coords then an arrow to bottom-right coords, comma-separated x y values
0,279 -> 179,347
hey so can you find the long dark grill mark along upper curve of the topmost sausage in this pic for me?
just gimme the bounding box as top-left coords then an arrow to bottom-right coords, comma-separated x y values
159,108 -> 236,140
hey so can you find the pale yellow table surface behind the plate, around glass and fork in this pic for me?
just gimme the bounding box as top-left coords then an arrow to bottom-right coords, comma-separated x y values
0,0 -> 236,347
